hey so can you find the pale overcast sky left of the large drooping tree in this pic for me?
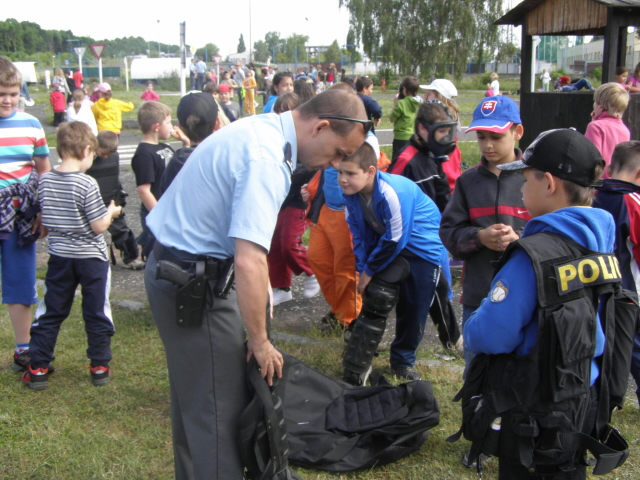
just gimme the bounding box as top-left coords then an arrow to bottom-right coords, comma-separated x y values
3,0 -> 349,56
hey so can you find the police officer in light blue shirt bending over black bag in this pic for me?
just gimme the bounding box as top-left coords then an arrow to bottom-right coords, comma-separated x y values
145,90 -> 371,480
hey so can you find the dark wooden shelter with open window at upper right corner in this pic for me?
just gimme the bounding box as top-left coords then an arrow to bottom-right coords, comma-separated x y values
496,0 -> 640,147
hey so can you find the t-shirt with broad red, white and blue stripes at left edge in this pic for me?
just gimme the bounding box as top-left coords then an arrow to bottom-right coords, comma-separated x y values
0,110 -> 49,188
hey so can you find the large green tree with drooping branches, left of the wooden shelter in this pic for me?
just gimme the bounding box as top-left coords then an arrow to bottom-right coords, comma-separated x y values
340,0 -> 502,76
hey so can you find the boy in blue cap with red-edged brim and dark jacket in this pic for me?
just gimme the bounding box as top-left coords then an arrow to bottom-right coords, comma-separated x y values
440,96 -> 531,386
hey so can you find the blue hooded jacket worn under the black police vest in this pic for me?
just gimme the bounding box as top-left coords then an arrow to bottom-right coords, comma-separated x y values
464,207 -> 615,385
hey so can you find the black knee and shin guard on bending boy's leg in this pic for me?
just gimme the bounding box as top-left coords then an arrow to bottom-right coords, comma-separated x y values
342,257 -> 409,383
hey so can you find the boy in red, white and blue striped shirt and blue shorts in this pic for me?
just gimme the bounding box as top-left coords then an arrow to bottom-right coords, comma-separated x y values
0,57 -> 51,371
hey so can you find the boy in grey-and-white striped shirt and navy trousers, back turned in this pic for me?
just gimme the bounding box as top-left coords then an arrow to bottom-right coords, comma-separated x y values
22,122 -> 122,390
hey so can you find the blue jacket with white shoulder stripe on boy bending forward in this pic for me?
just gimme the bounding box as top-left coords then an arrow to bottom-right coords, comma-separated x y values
344,172 -> 444,276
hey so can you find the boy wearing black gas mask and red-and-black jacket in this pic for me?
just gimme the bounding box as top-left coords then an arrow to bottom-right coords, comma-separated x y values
389,99 -> 462,355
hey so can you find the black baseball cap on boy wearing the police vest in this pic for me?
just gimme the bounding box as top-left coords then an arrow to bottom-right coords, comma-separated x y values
497,128 -> 604,187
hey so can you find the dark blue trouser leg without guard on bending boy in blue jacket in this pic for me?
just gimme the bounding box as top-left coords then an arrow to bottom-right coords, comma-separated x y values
390,256 -> 440,368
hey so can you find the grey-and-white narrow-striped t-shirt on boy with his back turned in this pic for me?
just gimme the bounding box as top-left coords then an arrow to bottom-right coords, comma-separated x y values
38,170 -> 108,262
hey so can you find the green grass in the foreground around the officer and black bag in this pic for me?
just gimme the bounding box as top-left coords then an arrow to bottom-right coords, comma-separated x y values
0,290 -> 640,480
